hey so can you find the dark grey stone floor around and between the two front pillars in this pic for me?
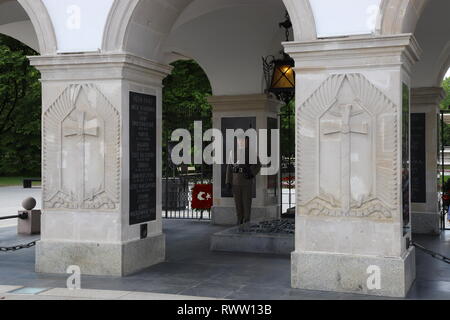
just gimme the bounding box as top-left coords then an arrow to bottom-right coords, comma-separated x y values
0,220 -> 450,300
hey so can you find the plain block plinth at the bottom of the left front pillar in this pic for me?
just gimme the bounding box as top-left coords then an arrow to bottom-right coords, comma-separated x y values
36,234 -> 165,277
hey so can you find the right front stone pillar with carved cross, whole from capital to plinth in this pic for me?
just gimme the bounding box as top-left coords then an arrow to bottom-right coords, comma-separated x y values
285,35 -> 420,297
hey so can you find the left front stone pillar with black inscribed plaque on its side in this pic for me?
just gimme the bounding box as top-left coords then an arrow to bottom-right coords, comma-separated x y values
31,54 -> 171,276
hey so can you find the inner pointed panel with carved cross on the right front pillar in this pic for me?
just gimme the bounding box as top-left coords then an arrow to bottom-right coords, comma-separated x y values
319,80 -> 374,213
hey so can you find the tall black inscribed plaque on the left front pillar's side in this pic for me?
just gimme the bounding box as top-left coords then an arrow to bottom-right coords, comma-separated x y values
129,92 -> 156,225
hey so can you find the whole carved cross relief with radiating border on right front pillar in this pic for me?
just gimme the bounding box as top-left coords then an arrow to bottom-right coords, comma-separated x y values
297,73 -> 399,219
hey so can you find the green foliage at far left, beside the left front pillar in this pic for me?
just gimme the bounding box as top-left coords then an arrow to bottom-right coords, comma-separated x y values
0,35 -> 41,176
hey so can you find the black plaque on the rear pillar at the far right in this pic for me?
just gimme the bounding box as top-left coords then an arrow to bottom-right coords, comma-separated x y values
411,113 -> 427,203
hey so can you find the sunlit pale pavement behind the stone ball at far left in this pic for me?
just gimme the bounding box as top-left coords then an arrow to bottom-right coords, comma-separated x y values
0,187 -> 41,227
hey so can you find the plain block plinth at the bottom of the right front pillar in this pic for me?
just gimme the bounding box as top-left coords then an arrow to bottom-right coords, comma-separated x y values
291,247 -> 416,298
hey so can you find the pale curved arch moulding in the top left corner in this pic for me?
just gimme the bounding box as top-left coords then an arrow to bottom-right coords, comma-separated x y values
17,0 -> 57,55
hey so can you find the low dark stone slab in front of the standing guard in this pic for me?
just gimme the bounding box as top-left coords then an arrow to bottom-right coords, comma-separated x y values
211,227 -> 295,255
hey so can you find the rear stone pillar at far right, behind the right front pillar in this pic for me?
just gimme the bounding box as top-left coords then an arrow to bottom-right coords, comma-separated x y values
411,88 -> 445,234
